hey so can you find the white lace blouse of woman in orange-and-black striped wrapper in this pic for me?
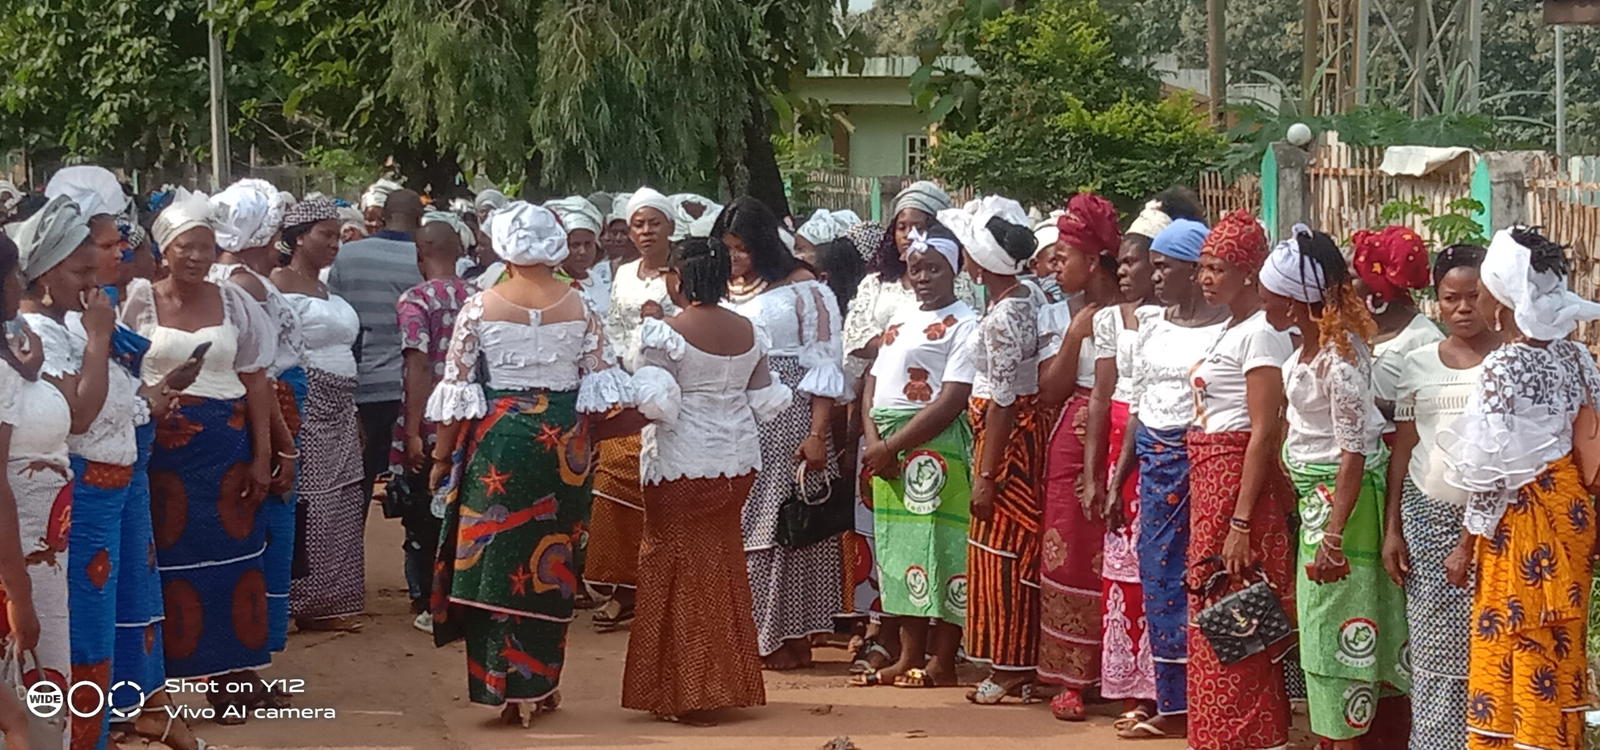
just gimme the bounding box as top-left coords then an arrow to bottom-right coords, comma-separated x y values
966,285 -> 1045,406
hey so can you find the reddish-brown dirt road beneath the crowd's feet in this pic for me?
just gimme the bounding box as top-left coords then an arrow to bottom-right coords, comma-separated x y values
172,509 -> 1203,750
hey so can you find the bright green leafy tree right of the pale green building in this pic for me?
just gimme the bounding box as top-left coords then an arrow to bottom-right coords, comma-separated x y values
928,0 -> 1222,208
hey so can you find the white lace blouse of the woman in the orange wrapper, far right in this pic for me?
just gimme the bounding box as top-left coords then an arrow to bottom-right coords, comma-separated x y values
1438,341 -> 1600,536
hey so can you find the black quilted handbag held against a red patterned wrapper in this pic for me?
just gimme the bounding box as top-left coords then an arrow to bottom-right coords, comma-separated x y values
1184,557 -> 1294,665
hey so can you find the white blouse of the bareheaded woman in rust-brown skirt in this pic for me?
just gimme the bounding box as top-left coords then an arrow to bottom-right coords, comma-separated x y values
634,318 -> 792,485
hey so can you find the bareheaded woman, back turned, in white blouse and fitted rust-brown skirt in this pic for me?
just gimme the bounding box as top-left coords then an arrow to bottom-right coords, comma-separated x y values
622,238 -> 790,724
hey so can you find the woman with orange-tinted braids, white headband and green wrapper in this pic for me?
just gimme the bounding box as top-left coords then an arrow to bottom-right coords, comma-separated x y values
1261,225 -> 1411,750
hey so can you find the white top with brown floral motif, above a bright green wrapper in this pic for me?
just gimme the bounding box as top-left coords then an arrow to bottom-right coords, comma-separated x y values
872,299 -> 978,409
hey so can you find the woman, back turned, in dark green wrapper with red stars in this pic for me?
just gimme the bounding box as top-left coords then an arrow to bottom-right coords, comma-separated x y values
427,201 -> 629,726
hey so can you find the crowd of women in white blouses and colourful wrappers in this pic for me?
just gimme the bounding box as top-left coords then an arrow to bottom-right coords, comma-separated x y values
0,166 -> 1600,750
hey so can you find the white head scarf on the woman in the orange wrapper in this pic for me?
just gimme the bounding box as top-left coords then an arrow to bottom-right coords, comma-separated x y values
1478,227 -> 1600,341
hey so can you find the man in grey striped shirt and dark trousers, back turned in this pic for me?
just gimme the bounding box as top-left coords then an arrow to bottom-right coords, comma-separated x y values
328,190 -> 422,497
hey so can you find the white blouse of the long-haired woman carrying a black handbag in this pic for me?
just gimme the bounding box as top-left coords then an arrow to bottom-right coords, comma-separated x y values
731,280 -> 845,398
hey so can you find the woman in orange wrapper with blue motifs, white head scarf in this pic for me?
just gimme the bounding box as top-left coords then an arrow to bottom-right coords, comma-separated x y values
1440,227 -> 1600,748
